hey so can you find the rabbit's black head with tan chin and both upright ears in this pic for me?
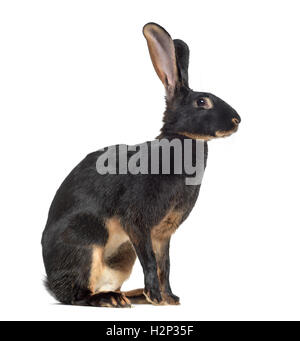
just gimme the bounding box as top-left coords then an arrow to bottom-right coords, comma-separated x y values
143,23 -> 241,140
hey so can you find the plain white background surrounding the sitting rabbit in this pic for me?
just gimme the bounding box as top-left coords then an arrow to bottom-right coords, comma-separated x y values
0,0 -> 300,321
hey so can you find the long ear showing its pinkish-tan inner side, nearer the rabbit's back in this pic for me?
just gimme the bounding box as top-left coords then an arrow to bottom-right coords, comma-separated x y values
143,23 -> 178,98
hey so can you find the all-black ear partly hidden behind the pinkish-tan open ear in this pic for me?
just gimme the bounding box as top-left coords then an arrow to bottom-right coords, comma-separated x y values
173,39 -> 190,87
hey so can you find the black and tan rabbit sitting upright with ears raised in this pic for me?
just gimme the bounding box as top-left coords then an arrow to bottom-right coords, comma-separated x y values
42,22 -> 241,307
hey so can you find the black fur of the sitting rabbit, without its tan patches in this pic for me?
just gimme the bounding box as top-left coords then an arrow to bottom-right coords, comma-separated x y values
42,23 -> 240,305
